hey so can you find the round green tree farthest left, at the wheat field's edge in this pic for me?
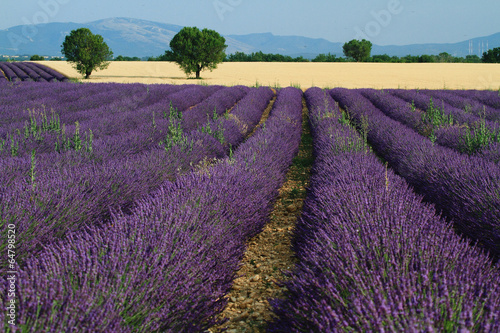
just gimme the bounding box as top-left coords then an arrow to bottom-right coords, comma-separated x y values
61,28 -> 113,79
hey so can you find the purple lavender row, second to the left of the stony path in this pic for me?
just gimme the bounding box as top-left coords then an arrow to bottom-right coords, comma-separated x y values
0,84 -> 272,267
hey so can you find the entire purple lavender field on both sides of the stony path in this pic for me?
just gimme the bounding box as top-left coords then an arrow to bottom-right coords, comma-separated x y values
0,74 -> 500,332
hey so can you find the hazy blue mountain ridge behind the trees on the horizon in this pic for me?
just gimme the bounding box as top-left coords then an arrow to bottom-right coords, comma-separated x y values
0,17 -> 500,58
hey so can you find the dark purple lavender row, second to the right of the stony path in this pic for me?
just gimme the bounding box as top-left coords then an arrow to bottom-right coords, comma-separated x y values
330,88 -> 500,260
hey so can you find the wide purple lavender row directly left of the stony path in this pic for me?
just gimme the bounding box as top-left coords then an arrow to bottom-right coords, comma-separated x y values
0,88 -> 302,332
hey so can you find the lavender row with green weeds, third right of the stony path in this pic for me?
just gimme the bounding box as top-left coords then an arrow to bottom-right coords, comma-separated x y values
359,89 -> 500,163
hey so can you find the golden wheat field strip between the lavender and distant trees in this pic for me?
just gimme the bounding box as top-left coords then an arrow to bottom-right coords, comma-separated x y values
40,61 -> 500,90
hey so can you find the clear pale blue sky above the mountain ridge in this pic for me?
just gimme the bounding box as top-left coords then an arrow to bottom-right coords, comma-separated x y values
0,0 -> 500,45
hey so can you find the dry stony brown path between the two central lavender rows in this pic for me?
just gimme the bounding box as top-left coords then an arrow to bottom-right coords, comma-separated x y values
209,98 -> 312,333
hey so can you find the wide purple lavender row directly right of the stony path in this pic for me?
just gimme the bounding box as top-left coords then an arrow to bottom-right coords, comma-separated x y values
270,88 -> 500,332
